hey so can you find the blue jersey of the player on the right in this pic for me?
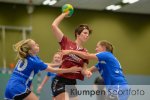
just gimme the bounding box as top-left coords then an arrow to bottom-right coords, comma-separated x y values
95,52 -> 127,85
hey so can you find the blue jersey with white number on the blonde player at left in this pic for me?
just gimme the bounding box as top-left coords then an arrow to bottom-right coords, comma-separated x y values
5,56 -> 47,99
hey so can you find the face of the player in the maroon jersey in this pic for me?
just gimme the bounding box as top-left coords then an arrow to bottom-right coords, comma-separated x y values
77,29 -> 89,42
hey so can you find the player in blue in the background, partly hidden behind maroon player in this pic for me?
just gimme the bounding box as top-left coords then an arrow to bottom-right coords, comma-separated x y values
37,52 -> 62,100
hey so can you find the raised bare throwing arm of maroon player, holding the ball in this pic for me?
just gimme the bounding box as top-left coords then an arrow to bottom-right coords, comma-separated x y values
52,12 -> 68,42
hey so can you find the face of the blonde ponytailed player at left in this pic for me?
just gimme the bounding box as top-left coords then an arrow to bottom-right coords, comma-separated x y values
29,40 -> 39,55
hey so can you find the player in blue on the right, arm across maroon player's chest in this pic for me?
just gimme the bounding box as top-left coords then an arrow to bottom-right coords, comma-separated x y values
62,40 -> 128,100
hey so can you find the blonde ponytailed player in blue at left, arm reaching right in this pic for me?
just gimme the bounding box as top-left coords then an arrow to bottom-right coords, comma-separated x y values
5,39 -> 81,100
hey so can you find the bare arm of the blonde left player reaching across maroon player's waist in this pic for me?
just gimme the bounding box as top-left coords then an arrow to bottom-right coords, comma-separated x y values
46,66 -> 82,74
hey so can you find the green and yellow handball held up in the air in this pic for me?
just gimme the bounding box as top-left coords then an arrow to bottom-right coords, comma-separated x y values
62,4 -> 74,17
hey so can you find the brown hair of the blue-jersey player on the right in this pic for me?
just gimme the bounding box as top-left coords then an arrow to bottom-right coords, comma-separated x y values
98,40 -> 113,53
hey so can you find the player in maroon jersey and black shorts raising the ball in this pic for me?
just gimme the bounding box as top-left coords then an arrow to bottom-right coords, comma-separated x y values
51,12 -> 92,100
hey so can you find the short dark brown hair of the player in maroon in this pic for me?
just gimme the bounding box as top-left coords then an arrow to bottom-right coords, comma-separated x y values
75,24 -> 92,38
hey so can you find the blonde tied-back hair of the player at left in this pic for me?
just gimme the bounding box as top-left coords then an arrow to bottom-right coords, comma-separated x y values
13,39 -> 32,59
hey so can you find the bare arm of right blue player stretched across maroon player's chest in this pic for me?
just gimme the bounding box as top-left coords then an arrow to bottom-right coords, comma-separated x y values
61,50 -> 98,60
